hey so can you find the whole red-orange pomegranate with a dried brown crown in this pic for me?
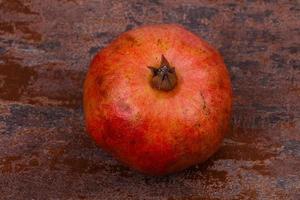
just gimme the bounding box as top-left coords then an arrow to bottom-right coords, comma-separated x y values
84,25 -> 232,175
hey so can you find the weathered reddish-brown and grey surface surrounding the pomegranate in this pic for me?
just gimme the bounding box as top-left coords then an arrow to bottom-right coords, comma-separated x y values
0,0 -> 300,200
